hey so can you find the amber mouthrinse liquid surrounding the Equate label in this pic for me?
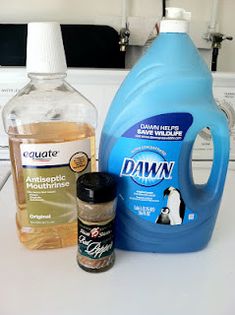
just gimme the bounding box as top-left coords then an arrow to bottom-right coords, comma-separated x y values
9,121 -> 96,249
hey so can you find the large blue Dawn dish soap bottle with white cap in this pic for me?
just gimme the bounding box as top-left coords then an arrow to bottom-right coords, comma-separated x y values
99,8 -> 229,252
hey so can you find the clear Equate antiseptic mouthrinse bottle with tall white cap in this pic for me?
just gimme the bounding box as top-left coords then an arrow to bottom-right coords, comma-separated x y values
3,23 -> 96,249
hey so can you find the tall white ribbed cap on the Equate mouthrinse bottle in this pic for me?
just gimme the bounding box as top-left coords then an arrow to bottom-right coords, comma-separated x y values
26,22 -> 67,74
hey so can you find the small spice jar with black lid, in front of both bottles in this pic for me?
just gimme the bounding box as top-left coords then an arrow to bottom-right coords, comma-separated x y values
77,172 -> 116,272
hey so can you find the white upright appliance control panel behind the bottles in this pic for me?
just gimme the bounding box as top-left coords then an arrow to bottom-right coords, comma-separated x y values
0,67 -> 235,187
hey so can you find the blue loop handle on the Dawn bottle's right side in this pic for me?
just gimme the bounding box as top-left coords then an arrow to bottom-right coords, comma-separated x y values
179,112 -> 230,215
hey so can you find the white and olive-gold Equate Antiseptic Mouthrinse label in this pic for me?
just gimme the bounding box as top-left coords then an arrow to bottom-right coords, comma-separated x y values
20,139 -> 91,226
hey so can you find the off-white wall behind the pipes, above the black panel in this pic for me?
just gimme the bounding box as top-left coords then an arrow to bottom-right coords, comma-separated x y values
0,0 -> 235,72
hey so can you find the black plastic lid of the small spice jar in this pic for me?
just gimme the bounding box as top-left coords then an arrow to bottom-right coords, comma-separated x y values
77,172 -> 117,203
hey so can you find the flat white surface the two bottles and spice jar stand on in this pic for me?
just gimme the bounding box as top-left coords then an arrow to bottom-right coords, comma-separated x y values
0,164 -> 235,315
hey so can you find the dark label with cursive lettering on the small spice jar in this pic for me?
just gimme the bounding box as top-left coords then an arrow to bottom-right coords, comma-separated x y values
78,219 -> 114,259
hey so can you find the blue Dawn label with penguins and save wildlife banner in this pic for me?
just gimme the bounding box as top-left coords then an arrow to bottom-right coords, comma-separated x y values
108,113 -> 197,225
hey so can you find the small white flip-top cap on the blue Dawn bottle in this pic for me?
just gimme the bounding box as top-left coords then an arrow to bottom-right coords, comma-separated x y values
160,8 -> 191,33
